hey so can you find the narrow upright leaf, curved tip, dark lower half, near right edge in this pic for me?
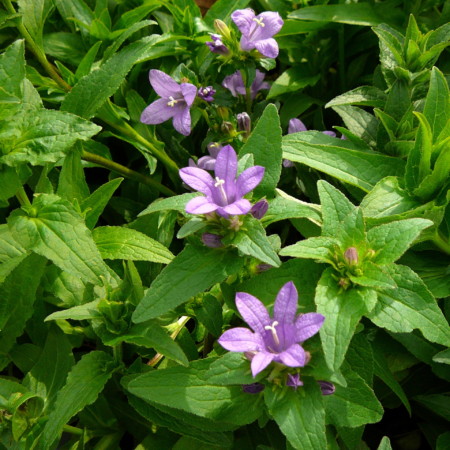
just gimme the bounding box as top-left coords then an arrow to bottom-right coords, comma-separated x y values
405,112 -> 433,192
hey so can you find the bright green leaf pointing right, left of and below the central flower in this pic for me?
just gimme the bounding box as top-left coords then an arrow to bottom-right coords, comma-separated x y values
92,227 -> 174,264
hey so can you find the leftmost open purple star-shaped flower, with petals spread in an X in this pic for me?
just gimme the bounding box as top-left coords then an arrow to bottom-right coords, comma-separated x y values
141,69 -> 197,136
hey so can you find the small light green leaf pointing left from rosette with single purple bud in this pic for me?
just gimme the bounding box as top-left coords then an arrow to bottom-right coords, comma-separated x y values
279,236 -> 339,264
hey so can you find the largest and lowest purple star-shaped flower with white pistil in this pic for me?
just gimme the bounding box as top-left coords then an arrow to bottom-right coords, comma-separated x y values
219,281 -> 325,376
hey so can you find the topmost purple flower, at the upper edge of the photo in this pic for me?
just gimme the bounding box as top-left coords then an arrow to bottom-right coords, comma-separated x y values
231,8 -> 284,58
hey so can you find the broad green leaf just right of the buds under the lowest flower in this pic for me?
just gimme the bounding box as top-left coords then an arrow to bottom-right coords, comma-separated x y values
324,363 -> 383,428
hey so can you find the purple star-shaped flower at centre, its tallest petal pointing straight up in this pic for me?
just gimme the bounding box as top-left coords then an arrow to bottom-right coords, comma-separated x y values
180,145 -> 265,218
